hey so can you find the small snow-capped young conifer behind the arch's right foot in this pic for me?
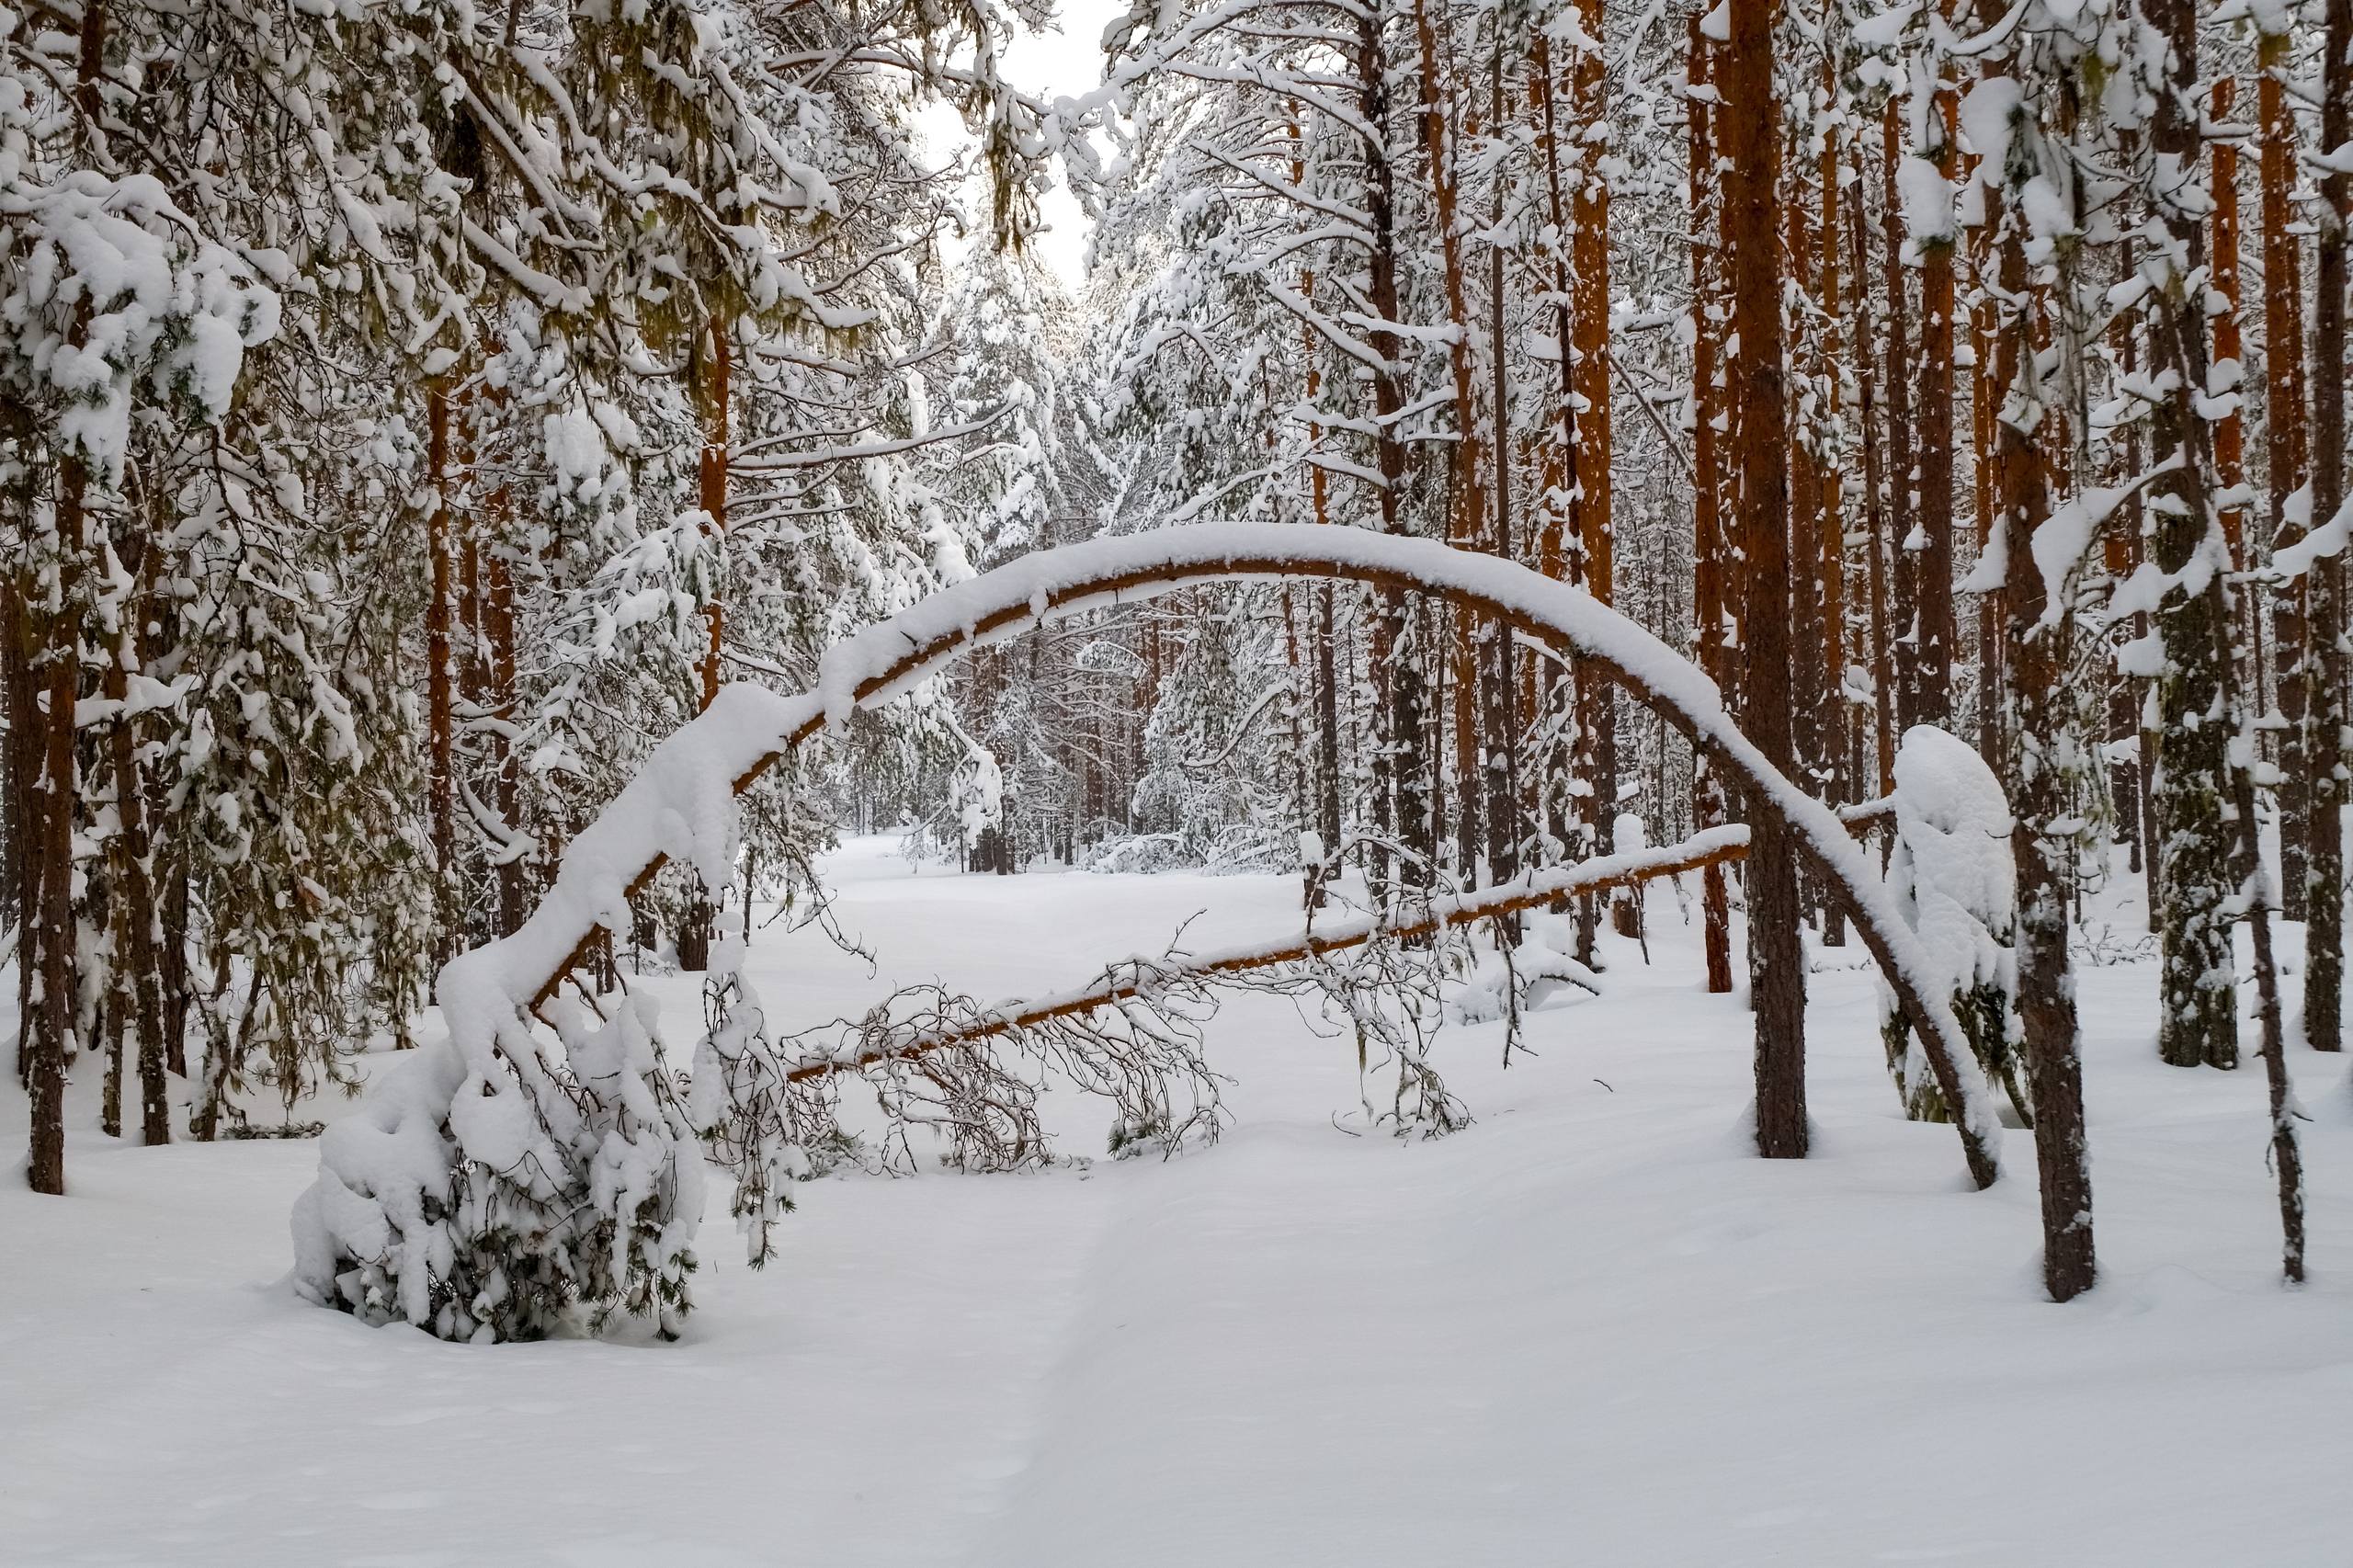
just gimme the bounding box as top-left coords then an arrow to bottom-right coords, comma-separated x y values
1882,725 -> 2026,1120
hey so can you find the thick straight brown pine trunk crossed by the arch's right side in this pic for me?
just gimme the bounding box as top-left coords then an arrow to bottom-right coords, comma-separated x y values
1722,0 -> 1807,1158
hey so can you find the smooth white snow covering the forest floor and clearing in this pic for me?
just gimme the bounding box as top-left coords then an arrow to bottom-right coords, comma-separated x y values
0,840 -> 2353,1568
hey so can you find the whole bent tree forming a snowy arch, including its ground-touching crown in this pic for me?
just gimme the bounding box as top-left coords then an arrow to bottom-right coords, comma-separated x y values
294,523 -> 1997,1337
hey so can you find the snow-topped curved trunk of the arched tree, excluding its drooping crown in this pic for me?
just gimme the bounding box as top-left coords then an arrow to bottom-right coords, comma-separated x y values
482,523 -> 1997,1187
